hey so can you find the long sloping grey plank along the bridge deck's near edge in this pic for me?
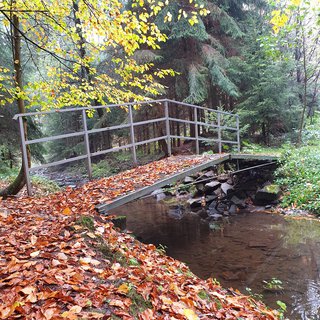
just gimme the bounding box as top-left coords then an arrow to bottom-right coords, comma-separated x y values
96,154 -> 231,213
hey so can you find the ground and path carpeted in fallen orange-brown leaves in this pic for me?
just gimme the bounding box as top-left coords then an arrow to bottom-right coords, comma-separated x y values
0,157 -> 280,320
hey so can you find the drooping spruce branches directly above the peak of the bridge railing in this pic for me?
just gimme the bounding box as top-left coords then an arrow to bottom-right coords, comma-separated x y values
151,1 -> 248,109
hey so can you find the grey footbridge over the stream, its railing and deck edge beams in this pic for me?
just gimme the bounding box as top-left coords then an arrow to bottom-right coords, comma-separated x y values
14,99 -> 276,211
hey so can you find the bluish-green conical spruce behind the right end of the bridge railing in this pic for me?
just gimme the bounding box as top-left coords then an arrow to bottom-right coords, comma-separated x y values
228,17 -> 299,145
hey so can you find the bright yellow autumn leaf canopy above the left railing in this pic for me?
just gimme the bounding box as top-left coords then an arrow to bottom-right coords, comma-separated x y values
0,0 -> 207,109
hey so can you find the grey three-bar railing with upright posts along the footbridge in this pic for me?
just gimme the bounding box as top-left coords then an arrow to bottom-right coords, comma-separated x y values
14,99 -> 240,195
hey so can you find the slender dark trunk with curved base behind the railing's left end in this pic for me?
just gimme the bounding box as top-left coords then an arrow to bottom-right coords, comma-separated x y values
0,10 -> 31,197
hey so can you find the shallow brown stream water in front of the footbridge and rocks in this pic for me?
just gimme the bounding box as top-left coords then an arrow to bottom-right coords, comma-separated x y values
112,198 -> 320,320
